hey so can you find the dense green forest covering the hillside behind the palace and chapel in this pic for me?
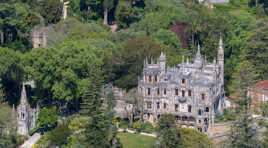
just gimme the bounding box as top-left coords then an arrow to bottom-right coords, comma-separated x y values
0,0 -> 268,148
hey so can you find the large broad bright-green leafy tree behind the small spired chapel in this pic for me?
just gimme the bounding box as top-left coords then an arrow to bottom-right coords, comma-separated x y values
25,40 -> 103,111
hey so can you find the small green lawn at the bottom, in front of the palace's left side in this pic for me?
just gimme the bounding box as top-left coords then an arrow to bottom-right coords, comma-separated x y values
119,132 -> 156,148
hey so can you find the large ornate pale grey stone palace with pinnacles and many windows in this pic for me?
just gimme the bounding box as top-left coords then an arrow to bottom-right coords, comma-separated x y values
138,39 -> 224,132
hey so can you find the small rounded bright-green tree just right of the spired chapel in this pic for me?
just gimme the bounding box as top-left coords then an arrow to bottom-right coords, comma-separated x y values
36,108 -> 58,132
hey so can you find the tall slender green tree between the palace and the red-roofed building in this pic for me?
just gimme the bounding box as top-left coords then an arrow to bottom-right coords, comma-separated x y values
229,61 -> 258,148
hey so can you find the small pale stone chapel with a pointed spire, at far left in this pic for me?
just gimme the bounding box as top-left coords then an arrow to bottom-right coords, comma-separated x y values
17,82 -> 39,135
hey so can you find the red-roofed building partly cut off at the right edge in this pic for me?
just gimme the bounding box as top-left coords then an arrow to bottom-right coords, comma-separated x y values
248,80 -> 268,109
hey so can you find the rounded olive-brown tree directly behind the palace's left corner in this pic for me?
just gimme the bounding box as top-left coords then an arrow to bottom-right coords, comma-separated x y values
114,37 -> 161,90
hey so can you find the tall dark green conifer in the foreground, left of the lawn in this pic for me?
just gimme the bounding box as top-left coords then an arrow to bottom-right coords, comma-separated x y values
79,69 -> 121,148
